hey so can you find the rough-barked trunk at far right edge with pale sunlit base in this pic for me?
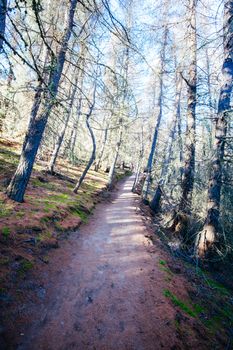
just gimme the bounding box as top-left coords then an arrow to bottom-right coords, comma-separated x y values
196,0 -> 233,258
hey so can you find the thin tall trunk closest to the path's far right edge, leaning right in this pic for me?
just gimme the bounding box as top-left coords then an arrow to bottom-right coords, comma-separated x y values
142,26 -> 168,200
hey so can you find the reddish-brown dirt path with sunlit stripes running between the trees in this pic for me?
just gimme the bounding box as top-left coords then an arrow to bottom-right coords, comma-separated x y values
11,177 -> 204,350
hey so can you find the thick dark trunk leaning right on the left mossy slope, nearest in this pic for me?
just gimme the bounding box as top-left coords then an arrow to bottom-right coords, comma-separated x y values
7,0 -> 78,202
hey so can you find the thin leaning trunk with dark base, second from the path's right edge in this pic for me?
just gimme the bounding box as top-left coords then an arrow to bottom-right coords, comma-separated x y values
150,71 -> 182,213
